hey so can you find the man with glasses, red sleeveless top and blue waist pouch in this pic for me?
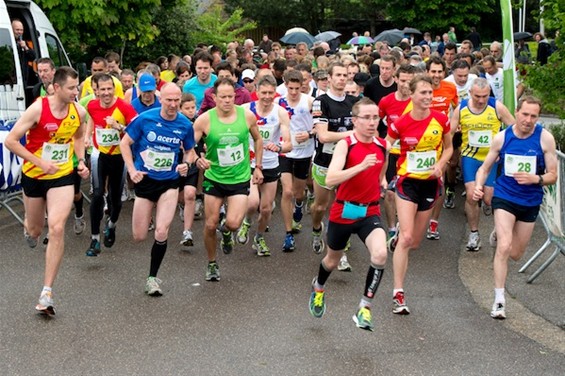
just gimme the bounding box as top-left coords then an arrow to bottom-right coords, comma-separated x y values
309,98 -> 390,331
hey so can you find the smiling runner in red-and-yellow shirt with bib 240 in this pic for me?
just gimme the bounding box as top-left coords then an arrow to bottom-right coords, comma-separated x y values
387,75 -> 452,315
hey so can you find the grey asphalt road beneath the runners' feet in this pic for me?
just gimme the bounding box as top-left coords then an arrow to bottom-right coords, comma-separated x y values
0,191 -> 565,375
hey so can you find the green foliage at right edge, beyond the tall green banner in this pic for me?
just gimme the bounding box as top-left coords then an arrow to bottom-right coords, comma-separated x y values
524,0 -> 565,119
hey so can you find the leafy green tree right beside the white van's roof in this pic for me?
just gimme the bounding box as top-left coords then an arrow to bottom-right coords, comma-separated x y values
36,0 -> 161,61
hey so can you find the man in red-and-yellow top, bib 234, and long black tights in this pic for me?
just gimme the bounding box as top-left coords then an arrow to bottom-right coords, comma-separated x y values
86,73 -> 137,257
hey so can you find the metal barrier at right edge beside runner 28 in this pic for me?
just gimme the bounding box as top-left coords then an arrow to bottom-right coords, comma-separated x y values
519,151 -> 565,283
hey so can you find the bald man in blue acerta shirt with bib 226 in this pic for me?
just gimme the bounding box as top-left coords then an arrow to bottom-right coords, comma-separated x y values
120,83 -> 194,296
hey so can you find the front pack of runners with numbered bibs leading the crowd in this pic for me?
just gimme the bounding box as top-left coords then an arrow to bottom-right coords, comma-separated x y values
6,38 -> 557,330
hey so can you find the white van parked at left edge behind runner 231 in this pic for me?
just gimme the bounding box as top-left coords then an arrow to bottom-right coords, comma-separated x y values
0,0 -> 71,197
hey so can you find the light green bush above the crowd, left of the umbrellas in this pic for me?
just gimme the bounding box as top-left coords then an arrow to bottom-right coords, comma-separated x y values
193,6 -> 257,46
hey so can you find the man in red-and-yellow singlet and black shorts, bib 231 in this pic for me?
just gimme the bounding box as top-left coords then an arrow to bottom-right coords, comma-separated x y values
5,67 -> 89,315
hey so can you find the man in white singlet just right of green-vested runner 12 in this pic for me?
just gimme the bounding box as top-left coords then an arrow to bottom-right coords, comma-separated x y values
237,76 -> 292,256
